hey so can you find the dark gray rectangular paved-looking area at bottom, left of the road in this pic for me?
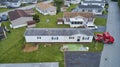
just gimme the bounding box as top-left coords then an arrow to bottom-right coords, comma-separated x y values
65,51 -> 101,67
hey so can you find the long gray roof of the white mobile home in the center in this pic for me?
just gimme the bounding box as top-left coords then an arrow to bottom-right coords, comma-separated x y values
25,28 -> 93,36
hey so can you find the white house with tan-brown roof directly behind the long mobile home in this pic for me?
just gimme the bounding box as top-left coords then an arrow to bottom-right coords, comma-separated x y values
63,12 -> 95,27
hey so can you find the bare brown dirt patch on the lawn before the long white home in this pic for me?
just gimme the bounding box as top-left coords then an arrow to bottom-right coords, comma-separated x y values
23,44 -> 39,52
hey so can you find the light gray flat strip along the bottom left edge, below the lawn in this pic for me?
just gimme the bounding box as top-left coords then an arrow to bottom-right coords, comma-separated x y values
0,62 -> 59,67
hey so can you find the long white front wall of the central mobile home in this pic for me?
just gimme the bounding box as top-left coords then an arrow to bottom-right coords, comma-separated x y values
25,35 -> 93,42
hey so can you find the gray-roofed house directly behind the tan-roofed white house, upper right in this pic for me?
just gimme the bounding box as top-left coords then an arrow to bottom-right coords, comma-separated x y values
72,5 -> 104,15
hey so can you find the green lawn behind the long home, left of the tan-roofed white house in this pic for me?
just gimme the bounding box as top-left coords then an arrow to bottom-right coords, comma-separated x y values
33,11 -> 70,28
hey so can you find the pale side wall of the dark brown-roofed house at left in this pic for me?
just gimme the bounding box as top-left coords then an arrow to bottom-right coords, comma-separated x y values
11,17 -> 33,28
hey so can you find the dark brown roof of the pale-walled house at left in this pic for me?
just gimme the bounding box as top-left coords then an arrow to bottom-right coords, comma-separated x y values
8,10 -> 31,21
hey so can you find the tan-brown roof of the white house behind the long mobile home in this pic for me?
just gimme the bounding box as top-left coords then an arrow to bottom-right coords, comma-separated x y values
64,12 -> 95,18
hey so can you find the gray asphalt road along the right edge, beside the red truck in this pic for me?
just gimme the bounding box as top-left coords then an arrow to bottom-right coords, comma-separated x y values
100,2 -> 120,67
